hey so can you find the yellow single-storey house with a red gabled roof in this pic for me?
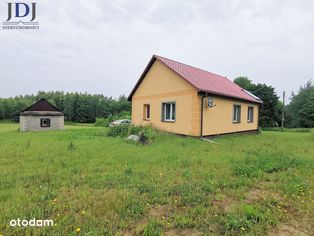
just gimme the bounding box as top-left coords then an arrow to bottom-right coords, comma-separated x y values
129,55 -> 262,137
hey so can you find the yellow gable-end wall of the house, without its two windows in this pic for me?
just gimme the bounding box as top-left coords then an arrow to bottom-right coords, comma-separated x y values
132,60 -> 200,136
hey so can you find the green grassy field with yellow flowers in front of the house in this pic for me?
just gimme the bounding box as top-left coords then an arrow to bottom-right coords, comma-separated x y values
0,123 -> 314,236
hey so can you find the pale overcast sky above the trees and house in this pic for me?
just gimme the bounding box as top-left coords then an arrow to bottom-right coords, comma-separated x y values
0,0 -> 314,100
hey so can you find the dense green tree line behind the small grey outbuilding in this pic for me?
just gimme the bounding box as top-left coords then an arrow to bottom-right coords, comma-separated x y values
0,91 -> 131,123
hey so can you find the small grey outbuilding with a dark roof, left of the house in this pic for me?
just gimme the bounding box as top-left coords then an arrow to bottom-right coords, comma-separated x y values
20,98 -> 64,131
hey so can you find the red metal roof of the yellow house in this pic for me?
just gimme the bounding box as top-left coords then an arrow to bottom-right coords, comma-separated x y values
129,55 -> 262,103
